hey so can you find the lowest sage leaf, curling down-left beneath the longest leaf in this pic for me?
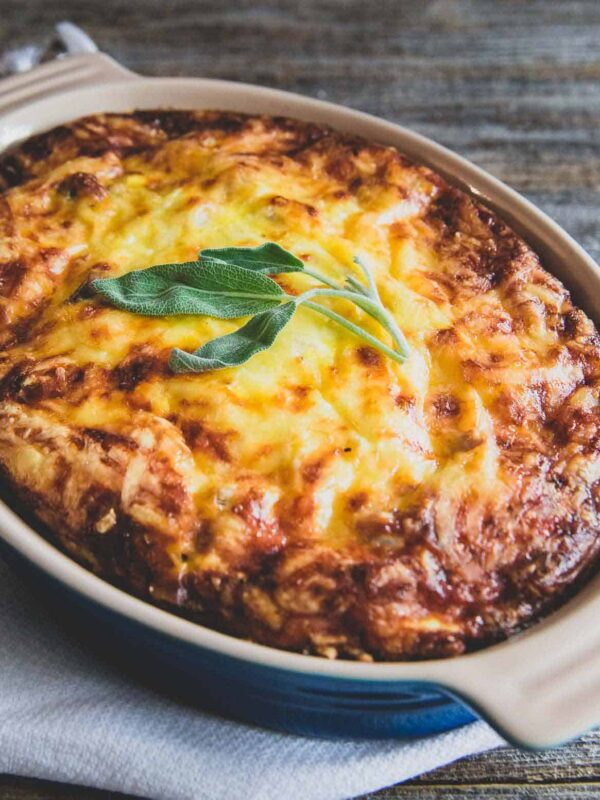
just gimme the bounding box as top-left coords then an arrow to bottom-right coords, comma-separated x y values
169,302 -> 296,373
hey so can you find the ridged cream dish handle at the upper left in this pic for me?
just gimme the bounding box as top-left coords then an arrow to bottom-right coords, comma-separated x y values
0,53 -> 139,119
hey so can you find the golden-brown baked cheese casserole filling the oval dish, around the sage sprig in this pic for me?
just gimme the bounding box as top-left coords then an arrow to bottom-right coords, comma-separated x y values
0,110 -> 600,660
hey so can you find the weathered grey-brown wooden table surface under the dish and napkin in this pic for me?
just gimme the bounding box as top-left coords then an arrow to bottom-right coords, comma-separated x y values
0,0 -> 600,800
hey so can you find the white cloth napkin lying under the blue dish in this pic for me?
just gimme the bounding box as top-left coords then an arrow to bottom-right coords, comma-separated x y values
0,562 -> 503,800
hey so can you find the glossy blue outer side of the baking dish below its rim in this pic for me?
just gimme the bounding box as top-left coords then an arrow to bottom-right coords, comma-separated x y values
1,542 -> 476,738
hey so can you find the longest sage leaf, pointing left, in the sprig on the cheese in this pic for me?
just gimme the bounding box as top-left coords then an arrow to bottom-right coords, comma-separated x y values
91,259 -> 286,319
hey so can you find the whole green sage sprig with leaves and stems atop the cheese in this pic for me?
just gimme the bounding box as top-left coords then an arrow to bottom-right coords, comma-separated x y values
91,242 -> 409,372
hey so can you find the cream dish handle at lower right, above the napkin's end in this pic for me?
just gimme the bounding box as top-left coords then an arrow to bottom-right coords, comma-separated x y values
435,575 -> 600,749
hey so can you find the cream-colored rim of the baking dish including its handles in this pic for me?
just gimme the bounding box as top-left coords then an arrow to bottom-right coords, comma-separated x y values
0,53 -> 600,747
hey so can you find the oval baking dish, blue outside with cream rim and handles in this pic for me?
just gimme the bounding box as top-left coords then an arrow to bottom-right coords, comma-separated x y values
0,54 -> 600,747
